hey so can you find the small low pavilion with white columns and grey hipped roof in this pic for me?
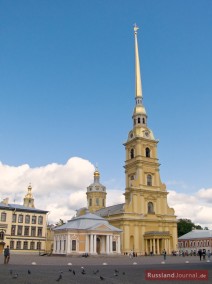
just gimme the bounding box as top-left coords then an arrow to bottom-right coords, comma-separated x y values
53,213 -> 122,255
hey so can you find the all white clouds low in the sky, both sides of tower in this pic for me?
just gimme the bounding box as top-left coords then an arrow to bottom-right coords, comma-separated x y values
0,160 -> 212,228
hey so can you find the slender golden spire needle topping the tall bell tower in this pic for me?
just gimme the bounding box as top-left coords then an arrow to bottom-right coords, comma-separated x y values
134,24 -> 142,98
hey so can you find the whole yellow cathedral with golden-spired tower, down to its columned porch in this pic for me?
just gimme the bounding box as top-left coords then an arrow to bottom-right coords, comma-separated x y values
93,26 -> 177,255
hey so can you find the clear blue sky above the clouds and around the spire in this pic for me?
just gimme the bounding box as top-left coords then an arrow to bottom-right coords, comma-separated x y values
0,0 -> 212,225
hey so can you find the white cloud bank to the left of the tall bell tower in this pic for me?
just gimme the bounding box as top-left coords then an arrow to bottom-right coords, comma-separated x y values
0,157 -> 124,223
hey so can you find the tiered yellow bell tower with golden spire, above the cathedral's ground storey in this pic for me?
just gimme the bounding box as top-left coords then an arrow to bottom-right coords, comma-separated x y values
124,25 -> 171,214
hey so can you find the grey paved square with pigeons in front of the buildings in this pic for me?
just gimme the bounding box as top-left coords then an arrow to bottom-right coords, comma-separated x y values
0,255 -> 212,284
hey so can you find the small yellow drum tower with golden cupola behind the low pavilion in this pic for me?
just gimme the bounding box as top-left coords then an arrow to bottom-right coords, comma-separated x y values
86,169 -> 107,212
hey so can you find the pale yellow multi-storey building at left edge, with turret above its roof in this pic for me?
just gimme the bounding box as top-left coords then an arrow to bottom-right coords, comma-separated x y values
0,186 -> 47,253
